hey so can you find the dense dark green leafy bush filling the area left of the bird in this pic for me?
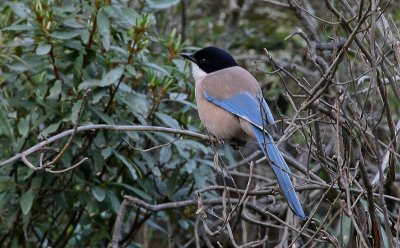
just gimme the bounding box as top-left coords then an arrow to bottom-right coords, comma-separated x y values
0,1 -> 213,247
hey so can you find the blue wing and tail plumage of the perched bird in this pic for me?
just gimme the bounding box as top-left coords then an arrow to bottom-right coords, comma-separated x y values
203,91 -> 306,220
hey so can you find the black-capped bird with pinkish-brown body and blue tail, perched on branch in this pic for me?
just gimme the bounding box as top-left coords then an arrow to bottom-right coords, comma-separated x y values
180,46 -> 307,220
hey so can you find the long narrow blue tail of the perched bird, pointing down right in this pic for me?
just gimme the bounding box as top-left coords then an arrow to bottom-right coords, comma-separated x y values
252,126 -> 306,220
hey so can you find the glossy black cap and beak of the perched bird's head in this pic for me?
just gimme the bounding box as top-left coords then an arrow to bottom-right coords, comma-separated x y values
181,46 -> 238,73
